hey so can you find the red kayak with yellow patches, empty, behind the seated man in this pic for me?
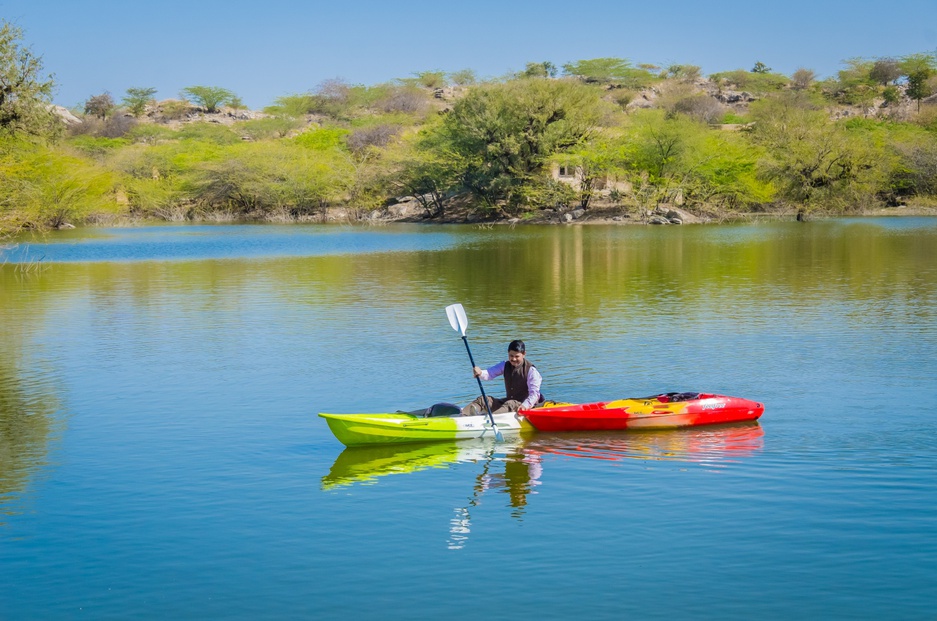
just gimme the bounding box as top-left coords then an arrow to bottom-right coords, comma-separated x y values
518,392 -> 765,431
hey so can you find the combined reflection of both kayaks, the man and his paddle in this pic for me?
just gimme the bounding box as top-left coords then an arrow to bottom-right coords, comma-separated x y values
322,422 -> 764,550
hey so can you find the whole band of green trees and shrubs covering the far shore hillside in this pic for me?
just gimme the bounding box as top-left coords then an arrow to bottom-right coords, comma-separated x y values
0,18 -> 937,237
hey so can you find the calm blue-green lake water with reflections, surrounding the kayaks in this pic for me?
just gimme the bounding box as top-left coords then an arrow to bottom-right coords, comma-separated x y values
0,218 -> 937,620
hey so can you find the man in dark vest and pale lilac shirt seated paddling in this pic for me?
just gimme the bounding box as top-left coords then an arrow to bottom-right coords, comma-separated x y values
462,341 -> 543,416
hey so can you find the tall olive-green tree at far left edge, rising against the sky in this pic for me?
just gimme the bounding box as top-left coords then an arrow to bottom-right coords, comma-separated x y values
0,21 -> 60,135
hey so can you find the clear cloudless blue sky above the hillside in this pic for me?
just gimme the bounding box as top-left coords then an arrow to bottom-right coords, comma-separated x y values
0,0 -> 937,109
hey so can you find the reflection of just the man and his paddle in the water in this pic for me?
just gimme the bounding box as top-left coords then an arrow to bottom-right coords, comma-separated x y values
446,446 -> 543,550
